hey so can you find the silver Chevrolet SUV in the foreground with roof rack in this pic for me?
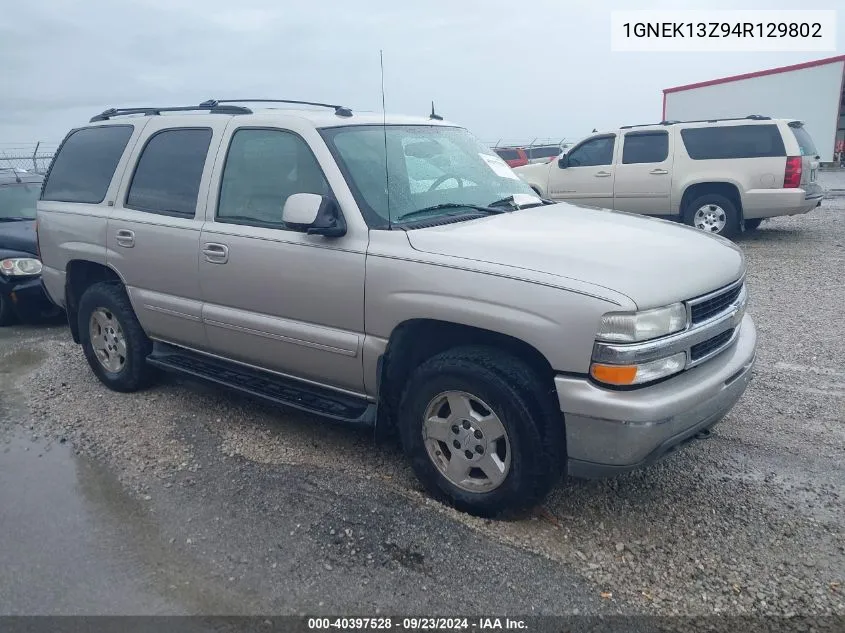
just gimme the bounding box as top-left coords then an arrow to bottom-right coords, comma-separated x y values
38,101 -> 757,515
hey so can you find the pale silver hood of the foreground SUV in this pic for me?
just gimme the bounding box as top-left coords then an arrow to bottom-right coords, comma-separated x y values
408,203 -> 745,309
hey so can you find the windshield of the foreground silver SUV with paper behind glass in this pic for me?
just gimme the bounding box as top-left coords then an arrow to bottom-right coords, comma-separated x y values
321,125 -> 540,228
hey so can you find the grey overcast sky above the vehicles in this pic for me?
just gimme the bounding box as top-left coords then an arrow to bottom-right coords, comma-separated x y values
0,0 -> 845,147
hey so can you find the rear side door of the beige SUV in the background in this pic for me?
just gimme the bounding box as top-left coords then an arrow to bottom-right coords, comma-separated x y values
613,130 -> 674,215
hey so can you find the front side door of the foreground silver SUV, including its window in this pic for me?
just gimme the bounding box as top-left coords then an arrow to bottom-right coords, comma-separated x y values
199,127 -> 368,393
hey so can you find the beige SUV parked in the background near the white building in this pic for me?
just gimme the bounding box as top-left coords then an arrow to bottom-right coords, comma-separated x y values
516,115 -> 822,237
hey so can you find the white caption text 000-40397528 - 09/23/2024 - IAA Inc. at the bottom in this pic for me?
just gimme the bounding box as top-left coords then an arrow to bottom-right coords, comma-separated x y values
308,617 -> 527,631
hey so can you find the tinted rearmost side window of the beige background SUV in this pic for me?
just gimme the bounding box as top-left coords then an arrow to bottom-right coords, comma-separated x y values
681,125 -> 786,160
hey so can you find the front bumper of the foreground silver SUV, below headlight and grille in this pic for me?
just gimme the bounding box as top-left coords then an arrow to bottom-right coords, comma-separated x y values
555,314 -> 757,477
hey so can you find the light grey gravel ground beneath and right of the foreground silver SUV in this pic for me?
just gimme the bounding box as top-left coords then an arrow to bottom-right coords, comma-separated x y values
11,197 -> 845,615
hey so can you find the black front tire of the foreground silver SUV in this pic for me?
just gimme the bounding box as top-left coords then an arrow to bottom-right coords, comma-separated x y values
398,347 -> 566,517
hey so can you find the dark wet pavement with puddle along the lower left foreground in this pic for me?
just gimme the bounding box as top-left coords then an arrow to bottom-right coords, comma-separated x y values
0,327 -> 619,615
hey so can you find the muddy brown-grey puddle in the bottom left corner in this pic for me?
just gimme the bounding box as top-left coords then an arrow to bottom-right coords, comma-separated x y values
0,334 -> 249,615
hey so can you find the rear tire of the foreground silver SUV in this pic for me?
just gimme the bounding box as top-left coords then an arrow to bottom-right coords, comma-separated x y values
78,281 -> 155,392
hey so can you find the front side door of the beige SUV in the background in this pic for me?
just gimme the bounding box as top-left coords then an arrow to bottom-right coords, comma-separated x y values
549,134 -> 616,209
